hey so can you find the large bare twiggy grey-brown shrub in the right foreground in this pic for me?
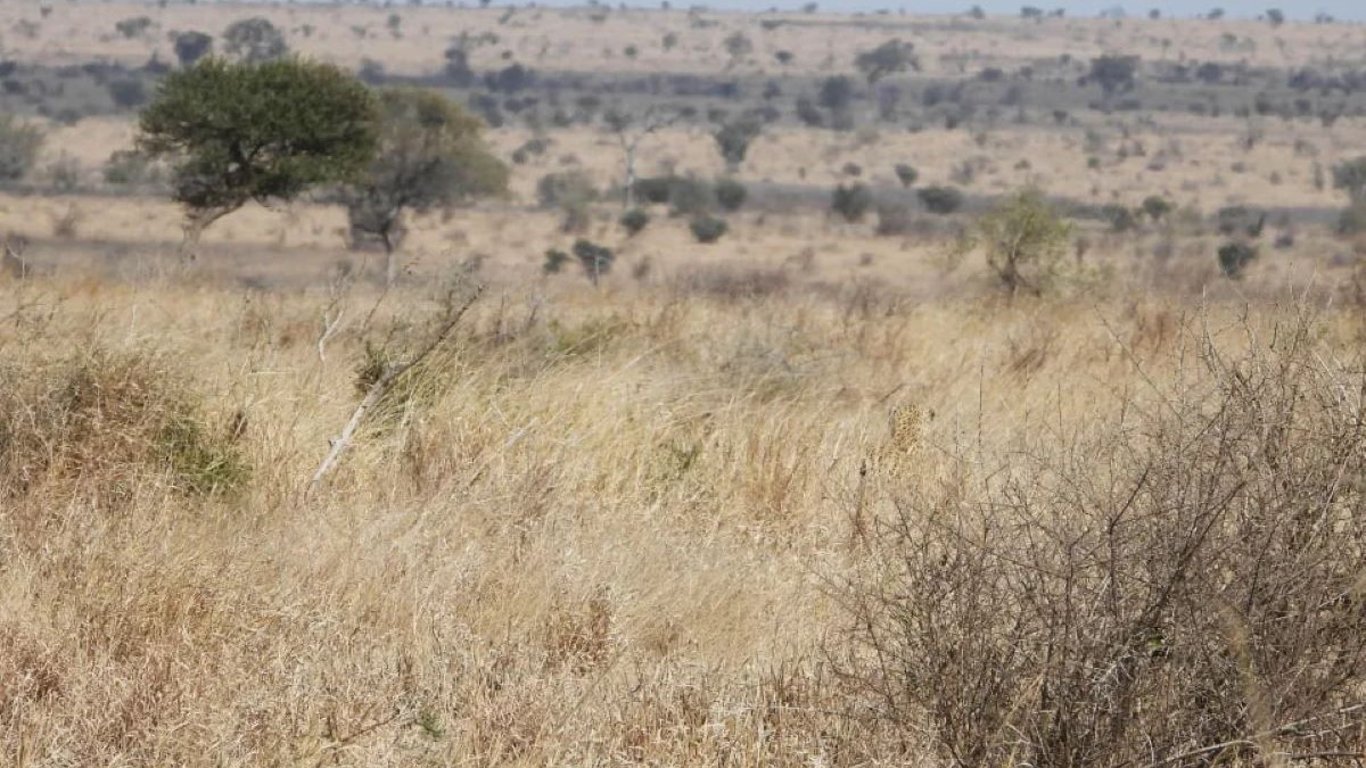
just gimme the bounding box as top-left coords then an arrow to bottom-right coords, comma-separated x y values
844,307 -> 1366,765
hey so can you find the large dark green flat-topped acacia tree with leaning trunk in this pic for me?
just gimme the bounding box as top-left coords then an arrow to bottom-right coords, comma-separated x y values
137,57 -> 378,261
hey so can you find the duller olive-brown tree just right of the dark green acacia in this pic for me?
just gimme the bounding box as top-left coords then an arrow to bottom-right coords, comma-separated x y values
343,87 -> 508,283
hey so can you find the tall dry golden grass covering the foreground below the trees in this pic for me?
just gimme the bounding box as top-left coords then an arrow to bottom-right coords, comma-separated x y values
0,267 -> 1361,767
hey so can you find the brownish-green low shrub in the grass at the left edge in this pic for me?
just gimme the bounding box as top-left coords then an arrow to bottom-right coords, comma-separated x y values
0,350 -> 250,504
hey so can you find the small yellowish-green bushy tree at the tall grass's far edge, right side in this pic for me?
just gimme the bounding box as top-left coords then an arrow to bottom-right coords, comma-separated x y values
964,189 -> 1072,295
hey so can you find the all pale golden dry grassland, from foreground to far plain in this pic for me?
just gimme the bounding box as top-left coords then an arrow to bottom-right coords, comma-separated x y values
0,3 -> 1366,768
